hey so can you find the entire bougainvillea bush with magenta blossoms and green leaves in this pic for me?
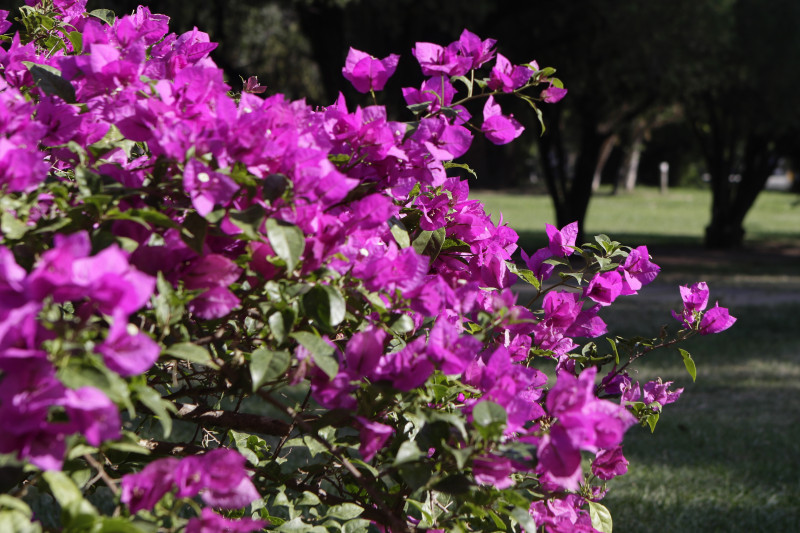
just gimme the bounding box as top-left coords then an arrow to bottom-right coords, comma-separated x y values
0,0 -> 735,533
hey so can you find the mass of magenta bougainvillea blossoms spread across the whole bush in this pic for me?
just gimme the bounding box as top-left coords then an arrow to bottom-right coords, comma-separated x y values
0,0 -> 735,533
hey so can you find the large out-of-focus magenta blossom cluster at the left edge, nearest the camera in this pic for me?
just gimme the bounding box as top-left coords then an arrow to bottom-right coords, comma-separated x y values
0,233 -> 155,469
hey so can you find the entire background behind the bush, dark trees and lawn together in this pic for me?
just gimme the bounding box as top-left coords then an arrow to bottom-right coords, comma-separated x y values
7,0 -> 800,532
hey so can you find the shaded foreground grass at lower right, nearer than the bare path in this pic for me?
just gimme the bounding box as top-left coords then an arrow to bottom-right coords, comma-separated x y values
604,303 -> 800,533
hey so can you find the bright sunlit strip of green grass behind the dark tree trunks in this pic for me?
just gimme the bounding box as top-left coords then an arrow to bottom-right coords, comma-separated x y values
471,187 -> 800,248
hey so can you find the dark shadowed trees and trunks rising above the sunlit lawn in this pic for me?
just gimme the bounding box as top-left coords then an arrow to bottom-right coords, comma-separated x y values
62,0 -> 800,249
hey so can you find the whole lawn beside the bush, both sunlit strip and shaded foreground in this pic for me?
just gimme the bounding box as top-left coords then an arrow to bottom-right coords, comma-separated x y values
472,185 -> 800,533
